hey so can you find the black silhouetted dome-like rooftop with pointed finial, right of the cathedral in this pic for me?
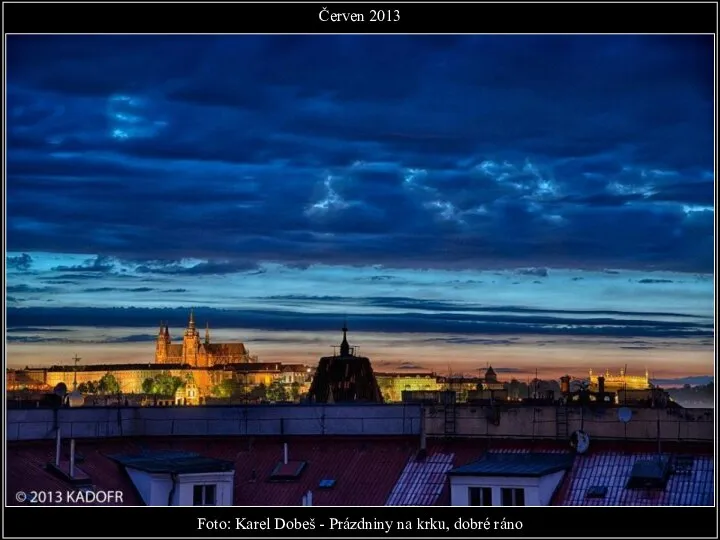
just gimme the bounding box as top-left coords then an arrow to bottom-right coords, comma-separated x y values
308,327 -> 383,403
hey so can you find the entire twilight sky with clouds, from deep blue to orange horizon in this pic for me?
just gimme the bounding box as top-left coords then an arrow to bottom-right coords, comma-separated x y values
6,36 -> 714,378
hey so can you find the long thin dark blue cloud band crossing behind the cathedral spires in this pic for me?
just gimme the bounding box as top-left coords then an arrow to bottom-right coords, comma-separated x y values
7,307 -> 713,339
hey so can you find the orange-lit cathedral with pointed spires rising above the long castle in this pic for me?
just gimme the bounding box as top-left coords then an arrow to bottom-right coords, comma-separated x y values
155,311 -> 257,367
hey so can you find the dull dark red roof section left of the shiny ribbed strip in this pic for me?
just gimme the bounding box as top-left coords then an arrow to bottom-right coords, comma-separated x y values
8,437 -> 417,506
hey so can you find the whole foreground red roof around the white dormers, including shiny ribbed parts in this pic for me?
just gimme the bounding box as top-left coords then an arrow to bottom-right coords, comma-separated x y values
7,436 -> 713,506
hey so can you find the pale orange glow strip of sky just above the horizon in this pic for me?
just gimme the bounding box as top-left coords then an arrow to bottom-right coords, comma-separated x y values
7,329 -> 714,380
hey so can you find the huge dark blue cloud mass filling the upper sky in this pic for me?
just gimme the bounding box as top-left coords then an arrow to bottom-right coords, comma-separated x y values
7,36 -> 714,279
